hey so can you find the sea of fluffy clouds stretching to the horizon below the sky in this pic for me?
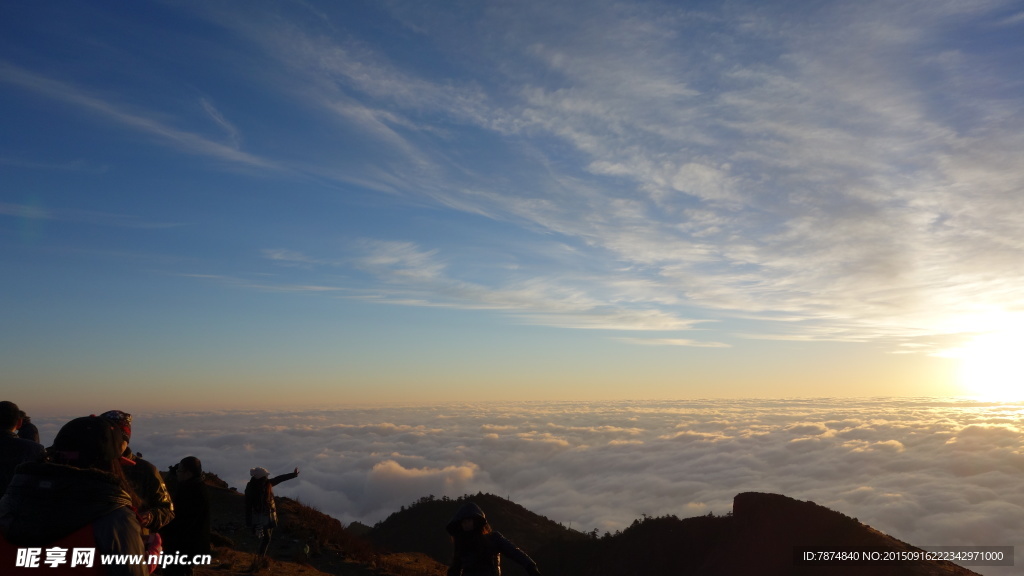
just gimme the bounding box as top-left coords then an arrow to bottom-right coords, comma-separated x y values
37,399 -> 1024,575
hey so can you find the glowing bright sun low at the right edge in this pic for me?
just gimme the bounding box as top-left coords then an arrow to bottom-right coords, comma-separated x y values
956,324 -> 1024,401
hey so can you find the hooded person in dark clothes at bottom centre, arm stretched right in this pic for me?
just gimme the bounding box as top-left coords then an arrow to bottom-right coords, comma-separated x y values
444,502 -> 541,576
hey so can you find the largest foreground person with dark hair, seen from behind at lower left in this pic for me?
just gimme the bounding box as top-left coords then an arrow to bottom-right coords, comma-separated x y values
0,416 -> 150,576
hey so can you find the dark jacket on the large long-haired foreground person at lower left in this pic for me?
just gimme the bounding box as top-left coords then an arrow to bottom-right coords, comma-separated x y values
0,462 -> 148,576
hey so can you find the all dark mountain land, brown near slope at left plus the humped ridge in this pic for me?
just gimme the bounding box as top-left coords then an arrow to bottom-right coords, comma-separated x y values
169,467 -> 976,576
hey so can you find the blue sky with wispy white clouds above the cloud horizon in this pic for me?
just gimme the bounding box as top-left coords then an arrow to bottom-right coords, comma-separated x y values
0,0 -> 1024,407
